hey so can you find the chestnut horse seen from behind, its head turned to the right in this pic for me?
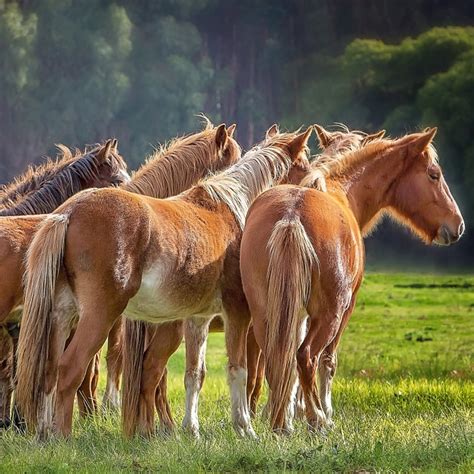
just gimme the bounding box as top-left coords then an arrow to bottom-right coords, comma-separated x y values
240,129 -> 464,433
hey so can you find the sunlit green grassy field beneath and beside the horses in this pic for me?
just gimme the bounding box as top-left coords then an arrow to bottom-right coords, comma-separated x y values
0,274 -> 474,473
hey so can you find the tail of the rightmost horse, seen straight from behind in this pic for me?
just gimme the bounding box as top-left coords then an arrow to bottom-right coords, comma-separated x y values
265,216 -> 318,430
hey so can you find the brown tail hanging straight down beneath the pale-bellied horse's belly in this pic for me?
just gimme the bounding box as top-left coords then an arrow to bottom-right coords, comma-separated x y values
122,319 -> 147,438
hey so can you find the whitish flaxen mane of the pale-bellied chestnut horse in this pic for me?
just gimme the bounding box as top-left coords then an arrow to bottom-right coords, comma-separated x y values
195,132 -> 308,228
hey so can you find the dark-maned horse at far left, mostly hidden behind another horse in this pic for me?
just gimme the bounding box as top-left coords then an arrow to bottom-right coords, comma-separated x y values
0,140 -> 130,428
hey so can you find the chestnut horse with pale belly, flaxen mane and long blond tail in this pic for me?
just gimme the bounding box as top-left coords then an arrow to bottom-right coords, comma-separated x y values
17,126 -> 312,438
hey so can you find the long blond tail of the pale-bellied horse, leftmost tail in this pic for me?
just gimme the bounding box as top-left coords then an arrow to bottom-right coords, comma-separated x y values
15,214 -> 69,427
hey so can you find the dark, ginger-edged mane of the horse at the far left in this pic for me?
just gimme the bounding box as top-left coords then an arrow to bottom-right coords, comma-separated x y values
0,145 -> 125,216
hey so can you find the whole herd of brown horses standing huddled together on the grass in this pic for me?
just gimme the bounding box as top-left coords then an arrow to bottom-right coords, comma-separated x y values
0,121 -> 464,439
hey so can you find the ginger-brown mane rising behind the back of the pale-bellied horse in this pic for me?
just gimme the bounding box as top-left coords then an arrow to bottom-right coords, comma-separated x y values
123,124 -> 221,198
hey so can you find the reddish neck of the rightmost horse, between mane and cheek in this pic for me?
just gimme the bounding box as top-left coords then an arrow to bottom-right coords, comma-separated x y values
328,146 -> 403,233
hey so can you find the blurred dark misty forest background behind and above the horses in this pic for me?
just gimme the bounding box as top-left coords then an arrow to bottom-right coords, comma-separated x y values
0,0 -> 474,271
